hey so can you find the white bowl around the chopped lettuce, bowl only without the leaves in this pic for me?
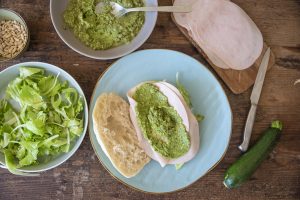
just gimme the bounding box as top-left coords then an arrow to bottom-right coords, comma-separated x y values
0,62 -> 88,173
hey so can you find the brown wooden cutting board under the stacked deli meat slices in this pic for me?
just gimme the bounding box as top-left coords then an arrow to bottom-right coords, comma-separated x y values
172,14 -> 275,94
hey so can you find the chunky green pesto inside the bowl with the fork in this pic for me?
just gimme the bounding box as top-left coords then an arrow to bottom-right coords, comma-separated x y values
63,0 -> 145,50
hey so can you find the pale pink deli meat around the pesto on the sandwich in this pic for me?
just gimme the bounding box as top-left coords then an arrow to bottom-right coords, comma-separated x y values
127,82 -> 200,167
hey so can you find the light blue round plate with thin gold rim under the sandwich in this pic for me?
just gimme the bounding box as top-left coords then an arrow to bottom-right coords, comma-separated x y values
89,50 -> 232,193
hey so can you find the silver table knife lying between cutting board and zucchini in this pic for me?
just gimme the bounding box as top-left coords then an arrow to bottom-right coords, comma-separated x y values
239,48 -> 271,152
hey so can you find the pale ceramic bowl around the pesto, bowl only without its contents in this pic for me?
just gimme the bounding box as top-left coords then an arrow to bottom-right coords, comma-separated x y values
50,0 -> 157,60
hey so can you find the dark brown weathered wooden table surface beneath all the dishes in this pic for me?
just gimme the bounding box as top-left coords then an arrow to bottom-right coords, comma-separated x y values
0,0 -> 300,200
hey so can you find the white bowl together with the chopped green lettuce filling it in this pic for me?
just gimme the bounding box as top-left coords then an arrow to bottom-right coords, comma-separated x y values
0,62 -> 88,176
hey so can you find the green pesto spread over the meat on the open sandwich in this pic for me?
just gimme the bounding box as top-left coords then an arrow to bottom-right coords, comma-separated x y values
133,83 -> 190,159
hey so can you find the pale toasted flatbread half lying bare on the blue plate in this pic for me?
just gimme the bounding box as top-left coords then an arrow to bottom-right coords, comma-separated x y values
93,93 -> 150,178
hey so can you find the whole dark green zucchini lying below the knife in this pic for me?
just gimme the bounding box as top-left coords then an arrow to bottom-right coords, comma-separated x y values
223,121 -> 282,188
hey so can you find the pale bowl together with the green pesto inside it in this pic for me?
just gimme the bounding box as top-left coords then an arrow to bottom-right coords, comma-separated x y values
50,0 -> 157,60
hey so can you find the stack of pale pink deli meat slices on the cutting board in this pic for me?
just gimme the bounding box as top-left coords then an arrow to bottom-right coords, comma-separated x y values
174,0 -> 263,70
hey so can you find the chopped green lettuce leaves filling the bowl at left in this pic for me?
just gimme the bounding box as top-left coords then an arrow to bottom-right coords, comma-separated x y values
0,67 -> 83,175
